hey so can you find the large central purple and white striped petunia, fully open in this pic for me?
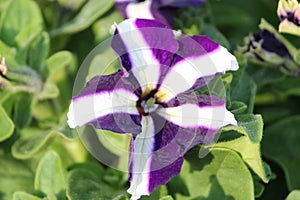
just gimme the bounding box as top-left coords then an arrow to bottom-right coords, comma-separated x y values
68,19 -> 238,200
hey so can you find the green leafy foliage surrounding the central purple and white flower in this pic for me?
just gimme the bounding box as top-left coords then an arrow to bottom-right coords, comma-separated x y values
0,0 -> 300,200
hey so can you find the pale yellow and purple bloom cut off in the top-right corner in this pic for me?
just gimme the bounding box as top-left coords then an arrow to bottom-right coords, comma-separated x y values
277,0 -> 300,36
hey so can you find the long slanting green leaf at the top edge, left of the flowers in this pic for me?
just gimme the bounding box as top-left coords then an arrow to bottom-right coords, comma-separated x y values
50,0 -> 114,37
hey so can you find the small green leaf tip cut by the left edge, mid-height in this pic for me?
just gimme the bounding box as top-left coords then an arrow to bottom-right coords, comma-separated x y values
0,106 -> 15,142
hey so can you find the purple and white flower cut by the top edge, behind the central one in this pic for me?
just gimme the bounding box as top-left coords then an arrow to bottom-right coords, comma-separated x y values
115,0 -> 204,26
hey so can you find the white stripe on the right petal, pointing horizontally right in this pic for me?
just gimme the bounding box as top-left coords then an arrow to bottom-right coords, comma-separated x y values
157,104 -> 237,130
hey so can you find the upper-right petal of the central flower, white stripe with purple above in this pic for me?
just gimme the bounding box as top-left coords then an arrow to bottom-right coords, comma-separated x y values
157,36 -> 238,102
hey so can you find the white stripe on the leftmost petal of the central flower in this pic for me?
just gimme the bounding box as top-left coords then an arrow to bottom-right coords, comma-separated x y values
67,89 -> 138,128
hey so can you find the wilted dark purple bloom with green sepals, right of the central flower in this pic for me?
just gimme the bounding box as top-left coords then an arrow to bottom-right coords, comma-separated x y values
239,20 -> 300,76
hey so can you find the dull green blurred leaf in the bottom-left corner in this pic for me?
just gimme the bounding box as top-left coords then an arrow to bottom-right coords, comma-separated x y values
0,155 -> 34,200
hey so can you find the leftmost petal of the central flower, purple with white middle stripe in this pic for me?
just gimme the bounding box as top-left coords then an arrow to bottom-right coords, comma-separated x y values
67,71 -> 141,134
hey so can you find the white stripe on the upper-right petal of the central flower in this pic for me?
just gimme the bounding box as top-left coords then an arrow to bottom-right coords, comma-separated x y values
157,46 -> 238,102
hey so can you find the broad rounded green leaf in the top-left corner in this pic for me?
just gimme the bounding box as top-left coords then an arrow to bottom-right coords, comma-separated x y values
0,0 -> 43,46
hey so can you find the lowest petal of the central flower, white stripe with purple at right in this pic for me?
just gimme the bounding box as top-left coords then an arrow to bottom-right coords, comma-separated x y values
127,116 -> 187,200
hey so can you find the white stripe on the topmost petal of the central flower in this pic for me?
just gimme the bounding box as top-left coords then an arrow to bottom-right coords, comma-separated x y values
117,19 -> 160,91
